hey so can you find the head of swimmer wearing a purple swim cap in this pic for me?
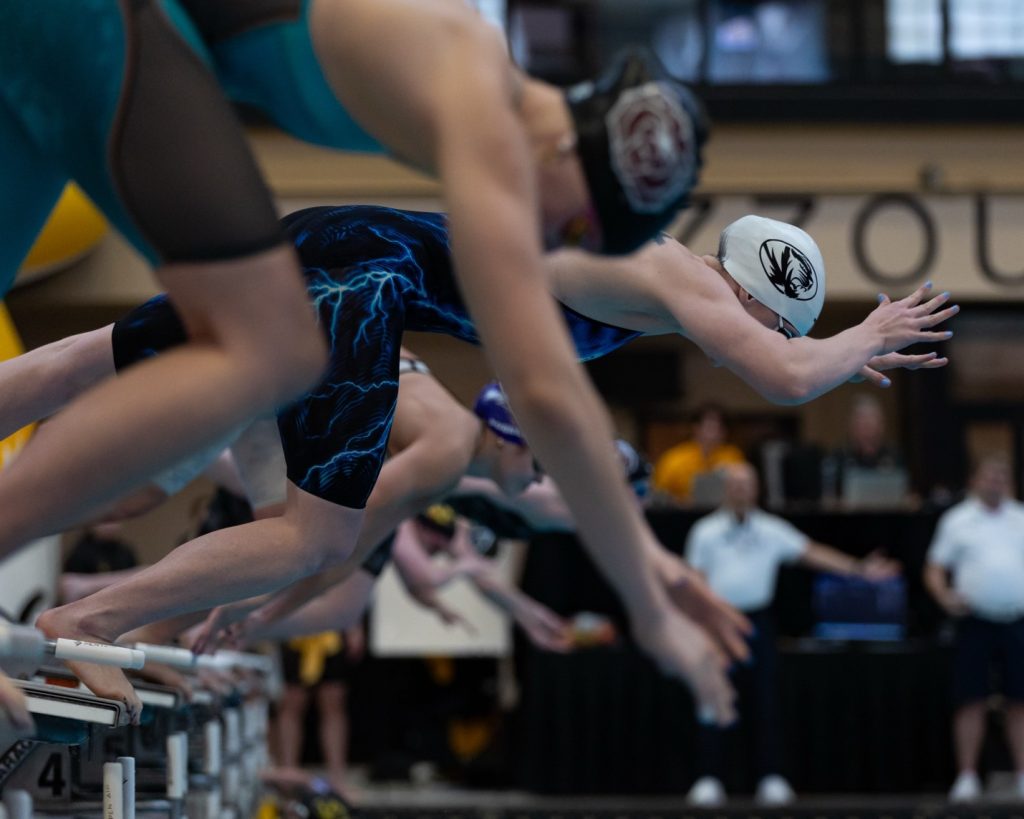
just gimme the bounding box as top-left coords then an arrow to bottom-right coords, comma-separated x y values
473,381 -> 543,494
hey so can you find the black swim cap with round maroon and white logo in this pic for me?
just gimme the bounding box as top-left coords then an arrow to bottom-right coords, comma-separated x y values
565,48 -> 708,254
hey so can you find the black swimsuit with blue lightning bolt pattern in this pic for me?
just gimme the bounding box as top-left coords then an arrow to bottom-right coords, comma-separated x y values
114,206 -> 641,509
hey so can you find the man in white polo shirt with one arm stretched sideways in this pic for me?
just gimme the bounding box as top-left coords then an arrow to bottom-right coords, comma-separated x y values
686,464 -> 899,807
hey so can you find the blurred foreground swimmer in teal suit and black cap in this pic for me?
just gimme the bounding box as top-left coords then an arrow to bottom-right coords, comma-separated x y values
0,0 -> 705,581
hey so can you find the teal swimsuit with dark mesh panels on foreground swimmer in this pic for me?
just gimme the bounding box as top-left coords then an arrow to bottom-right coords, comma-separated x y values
0,0 -> 381,295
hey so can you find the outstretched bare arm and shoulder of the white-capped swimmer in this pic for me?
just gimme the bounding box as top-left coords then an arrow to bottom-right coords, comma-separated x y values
549,246 -> 958,404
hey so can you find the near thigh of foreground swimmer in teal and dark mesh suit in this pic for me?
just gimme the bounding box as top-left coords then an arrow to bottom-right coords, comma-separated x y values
0,0 -> 282,264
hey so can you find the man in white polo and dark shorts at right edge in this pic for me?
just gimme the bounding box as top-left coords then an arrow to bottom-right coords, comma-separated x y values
925,455 -> 1024,802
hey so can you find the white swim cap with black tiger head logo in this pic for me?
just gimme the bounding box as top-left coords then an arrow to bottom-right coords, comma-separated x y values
718,216 -> 825,336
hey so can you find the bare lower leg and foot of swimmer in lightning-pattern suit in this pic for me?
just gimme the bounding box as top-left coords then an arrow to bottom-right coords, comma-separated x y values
37,483 -> 364,720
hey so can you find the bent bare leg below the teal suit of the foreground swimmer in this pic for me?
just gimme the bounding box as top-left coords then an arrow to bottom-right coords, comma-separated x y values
0,247 -> 325,556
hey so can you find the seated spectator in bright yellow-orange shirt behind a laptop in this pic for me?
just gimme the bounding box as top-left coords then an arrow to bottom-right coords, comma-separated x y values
653,404 -> 745,505
